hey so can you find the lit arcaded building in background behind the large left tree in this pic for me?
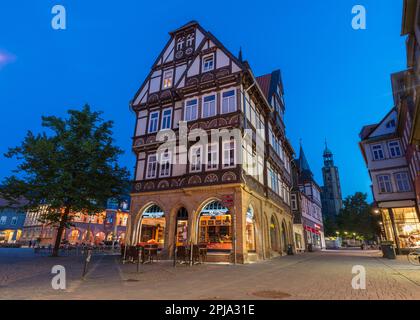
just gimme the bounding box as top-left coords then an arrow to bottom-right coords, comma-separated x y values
21,198 -> 129,245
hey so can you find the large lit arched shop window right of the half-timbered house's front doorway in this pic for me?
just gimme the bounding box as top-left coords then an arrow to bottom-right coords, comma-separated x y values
198,200 -> 232,251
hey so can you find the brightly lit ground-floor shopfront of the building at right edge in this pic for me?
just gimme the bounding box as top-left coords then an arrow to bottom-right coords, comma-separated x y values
381,207 -> 420,250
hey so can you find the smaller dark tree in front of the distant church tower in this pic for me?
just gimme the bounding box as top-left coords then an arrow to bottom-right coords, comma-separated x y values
337,192 -> 380,239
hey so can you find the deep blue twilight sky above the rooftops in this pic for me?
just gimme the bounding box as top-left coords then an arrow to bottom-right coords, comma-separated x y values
0,0 -> 406,200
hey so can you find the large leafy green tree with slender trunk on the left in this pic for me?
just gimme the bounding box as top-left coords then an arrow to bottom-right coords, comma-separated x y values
0,105 -> 129,256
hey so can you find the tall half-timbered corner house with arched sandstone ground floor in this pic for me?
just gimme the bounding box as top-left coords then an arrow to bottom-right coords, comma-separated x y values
127,21 -> 293,263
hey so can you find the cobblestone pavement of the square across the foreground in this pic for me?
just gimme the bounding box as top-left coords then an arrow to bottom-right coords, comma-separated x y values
0,249 -> 420,300
